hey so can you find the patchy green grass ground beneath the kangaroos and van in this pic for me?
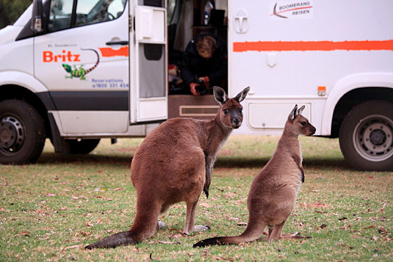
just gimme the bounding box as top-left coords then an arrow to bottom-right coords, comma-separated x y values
0,136 -> 393,261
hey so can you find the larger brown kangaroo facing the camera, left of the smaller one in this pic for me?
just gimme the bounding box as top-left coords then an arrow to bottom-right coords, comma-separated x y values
85,86 -> 250,249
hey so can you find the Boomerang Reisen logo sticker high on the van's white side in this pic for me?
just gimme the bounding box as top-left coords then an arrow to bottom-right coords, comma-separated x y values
269,0 -> 313,19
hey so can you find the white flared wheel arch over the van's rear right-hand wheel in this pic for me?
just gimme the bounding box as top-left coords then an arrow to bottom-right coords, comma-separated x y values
321,73 -> 393,138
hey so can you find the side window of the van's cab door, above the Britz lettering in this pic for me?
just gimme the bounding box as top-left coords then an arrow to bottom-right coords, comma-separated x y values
48,0 -> 127,32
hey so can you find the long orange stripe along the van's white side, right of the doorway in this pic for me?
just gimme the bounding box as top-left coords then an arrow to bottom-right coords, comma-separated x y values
233,40 -> 393,52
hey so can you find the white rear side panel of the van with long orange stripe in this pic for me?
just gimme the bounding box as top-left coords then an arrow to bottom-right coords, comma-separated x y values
228,0 -> 393,136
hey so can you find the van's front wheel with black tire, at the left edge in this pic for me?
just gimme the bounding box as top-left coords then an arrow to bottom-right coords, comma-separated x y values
0,99 -> 46,165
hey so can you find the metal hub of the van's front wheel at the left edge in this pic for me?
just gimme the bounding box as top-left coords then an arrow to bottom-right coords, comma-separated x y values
0,117 -> 24,152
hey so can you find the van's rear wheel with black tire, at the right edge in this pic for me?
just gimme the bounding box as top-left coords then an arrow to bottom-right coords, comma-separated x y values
339,100 -> 393,171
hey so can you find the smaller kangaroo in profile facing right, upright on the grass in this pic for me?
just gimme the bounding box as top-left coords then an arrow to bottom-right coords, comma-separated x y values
193,105 -> 315,247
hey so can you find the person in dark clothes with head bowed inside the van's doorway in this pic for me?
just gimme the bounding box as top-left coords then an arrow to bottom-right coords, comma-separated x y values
180,34 -> 228,96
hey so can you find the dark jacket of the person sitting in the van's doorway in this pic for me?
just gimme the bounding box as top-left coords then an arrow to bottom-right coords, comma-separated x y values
180,34 -> 228,89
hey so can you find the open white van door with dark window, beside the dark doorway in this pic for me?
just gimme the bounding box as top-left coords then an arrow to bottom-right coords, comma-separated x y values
130,0 -> 168,123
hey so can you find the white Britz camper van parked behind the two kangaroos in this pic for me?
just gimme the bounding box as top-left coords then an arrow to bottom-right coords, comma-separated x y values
0,0 -> 393,170
